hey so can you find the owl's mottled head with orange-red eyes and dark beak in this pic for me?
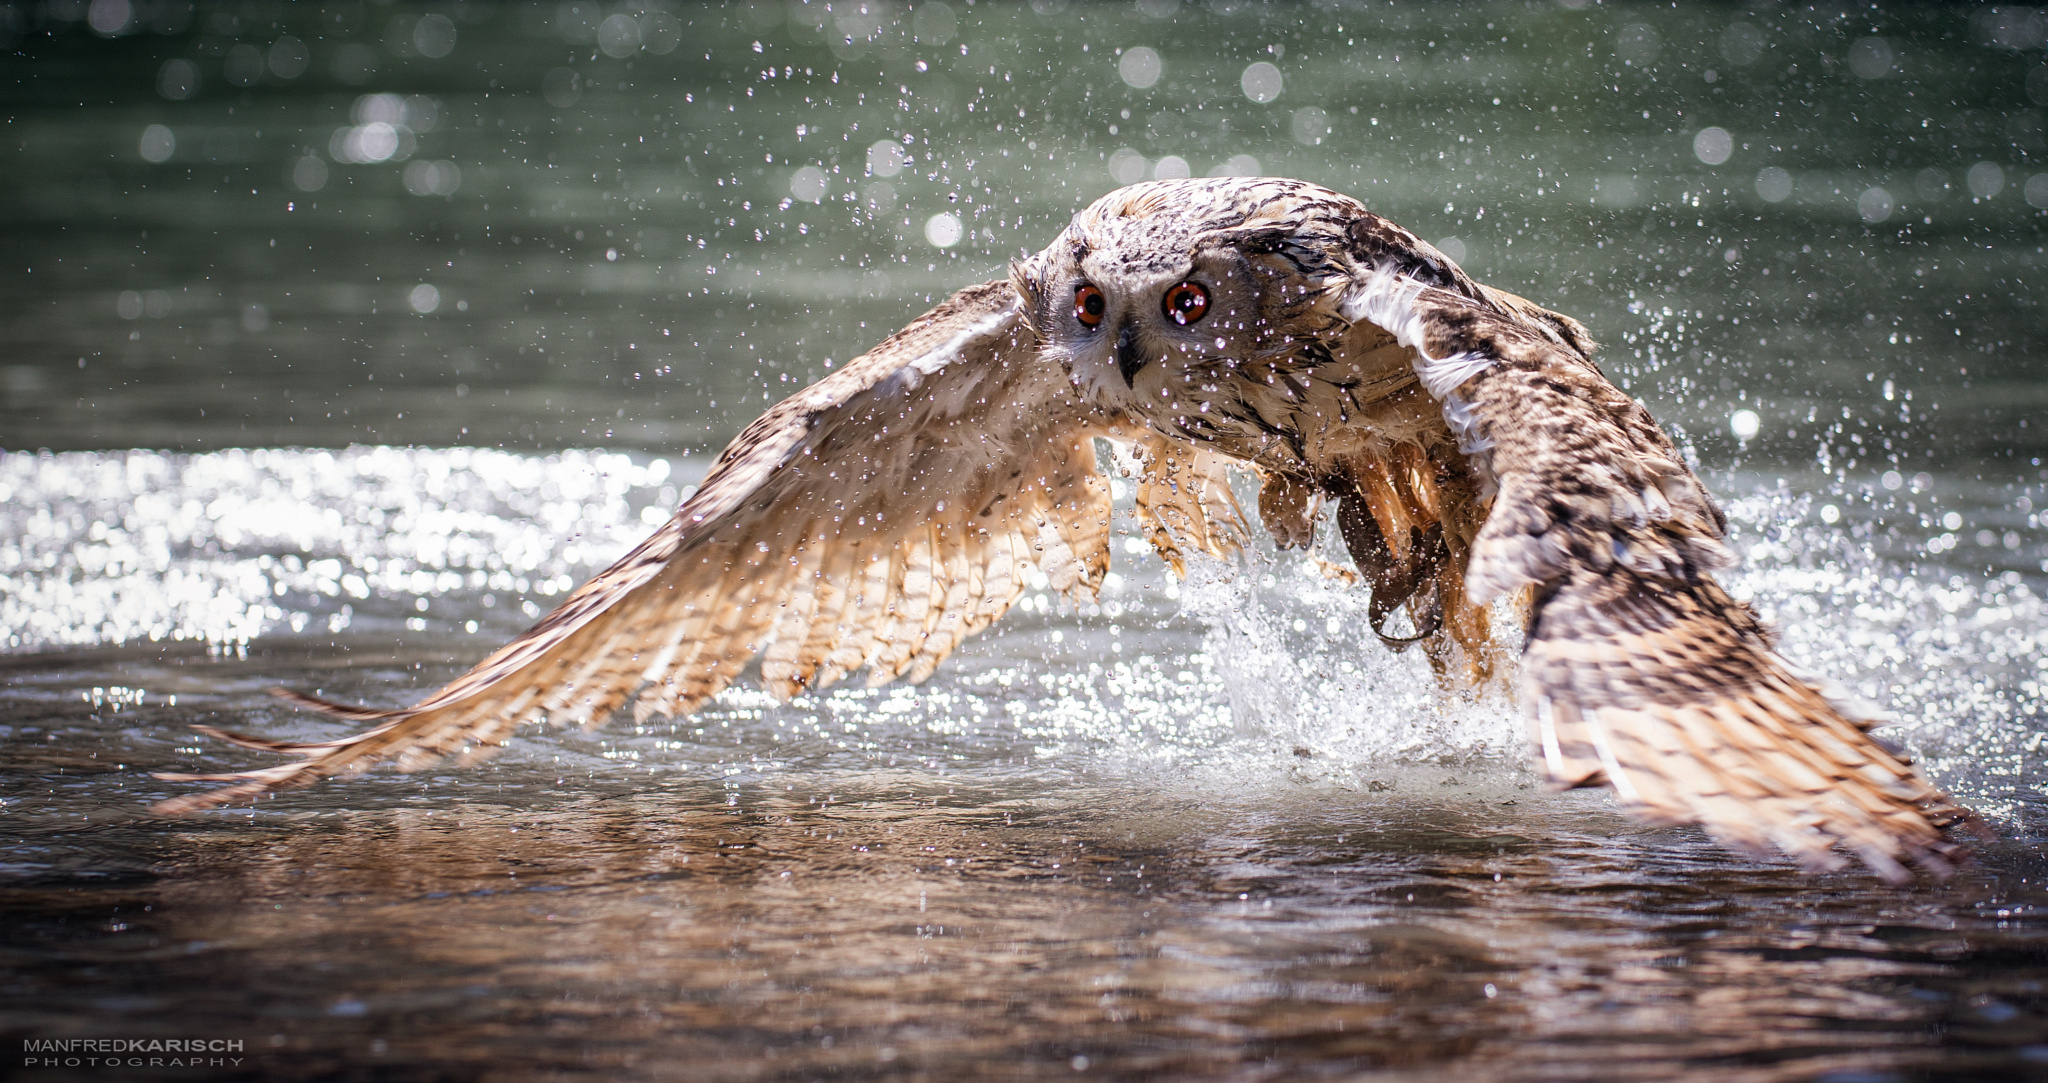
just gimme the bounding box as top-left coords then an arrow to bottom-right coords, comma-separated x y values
1012,178 -> 1456,403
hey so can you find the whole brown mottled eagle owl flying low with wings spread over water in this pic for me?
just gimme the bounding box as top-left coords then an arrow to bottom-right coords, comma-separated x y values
160,178 -> 1964,878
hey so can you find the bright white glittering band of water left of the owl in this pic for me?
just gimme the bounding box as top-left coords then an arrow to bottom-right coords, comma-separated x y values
0,446 -> 688,649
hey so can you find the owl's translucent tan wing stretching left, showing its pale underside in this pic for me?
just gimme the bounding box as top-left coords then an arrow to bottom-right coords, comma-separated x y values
158,283 -> 1155,813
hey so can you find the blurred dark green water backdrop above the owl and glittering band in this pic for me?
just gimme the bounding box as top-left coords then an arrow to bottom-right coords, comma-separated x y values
0,0 -> 2048,472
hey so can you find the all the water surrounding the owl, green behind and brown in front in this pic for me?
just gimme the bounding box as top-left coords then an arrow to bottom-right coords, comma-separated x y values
0,0 -> 2048,1079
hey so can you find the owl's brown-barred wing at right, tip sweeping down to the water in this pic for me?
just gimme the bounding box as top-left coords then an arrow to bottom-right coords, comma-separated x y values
1346,272 -> 1964,878
